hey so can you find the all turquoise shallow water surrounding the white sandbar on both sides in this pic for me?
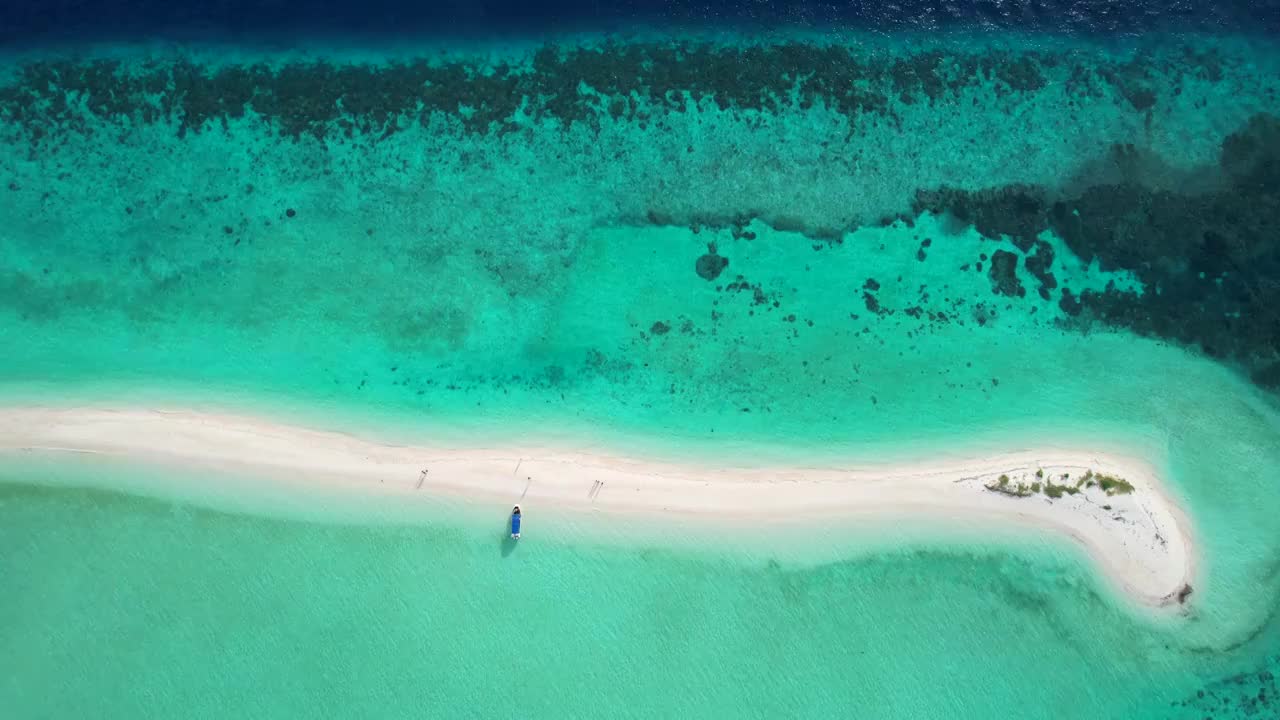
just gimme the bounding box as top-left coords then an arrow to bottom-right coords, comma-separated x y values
0,32 -> 1280,717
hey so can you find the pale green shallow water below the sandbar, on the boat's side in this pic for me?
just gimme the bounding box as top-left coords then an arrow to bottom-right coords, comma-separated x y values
0,476 -> 1276,717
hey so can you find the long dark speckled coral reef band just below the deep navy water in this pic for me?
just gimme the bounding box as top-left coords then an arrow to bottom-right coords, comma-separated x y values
0,40 -> 1224,138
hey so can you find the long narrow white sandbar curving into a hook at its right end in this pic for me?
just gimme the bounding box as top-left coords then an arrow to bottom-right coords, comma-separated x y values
0,406 -> 1196,607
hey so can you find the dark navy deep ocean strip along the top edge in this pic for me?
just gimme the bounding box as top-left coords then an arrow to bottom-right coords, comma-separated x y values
0,0 -> 1280,44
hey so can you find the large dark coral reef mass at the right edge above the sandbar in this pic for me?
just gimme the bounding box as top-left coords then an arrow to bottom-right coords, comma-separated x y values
915,114 -> 1280,387
